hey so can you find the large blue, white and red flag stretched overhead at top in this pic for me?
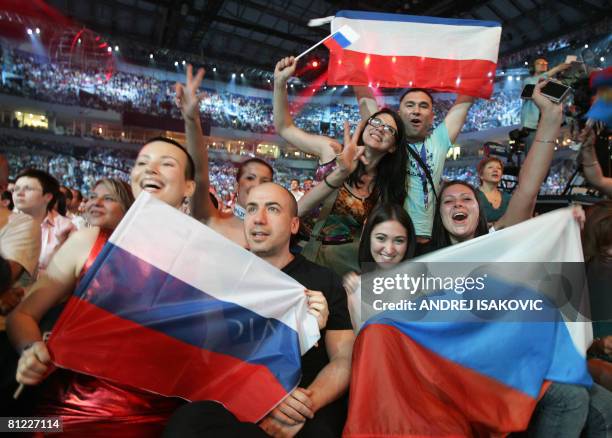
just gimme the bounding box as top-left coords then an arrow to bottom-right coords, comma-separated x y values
328,11 -> 501,98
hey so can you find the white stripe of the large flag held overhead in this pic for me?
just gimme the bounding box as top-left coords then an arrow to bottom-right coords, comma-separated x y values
331,17 -> 501,63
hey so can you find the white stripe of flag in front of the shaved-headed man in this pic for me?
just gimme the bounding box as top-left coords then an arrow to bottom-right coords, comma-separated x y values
109,192 -> 320,352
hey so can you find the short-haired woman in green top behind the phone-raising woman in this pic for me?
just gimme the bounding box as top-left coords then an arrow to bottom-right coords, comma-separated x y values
476,157 -> 512,225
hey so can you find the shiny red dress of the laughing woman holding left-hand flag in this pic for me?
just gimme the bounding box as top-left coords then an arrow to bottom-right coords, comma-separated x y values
36,230 -> 184,438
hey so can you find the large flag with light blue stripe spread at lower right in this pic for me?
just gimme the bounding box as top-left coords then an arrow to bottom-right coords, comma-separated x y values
343,209 -> 592,437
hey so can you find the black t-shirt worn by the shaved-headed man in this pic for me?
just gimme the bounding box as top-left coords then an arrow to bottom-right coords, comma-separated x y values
282,254 -> 353,387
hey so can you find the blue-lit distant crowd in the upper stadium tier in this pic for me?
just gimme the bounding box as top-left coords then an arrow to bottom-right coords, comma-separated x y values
0,47 -> 521,137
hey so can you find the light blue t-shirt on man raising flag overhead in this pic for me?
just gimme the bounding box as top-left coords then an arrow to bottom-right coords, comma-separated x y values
404,122 -> 452,237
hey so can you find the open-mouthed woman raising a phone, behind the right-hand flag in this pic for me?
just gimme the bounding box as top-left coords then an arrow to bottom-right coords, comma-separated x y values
414,82 -> 610,437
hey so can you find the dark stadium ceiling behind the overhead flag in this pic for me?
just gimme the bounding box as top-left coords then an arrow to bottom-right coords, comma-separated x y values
47,0 -> 612,72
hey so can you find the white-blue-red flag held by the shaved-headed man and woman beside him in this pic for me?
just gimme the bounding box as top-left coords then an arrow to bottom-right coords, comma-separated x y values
48,193 -> 320,422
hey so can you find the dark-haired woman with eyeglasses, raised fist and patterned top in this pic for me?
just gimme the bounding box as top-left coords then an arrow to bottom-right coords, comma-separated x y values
274,57 -> 407,275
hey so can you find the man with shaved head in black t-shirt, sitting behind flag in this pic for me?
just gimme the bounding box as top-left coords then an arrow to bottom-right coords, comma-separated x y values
164,183 -> 355,438
